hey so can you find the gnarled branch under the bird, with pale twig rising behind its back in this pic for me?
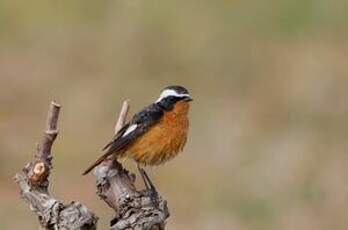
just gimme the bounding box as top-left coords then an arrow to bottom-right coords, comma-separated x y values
95,101 -> 169,230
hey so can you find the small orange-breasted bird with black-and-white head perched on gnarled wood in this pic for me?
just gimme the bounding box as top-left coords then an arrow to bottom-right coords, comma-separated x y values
83,86 -> 192,188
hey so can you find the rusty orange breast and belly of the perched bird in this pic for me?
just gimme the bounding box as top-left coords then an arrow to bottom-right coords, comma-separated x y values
124,101 -> 189,165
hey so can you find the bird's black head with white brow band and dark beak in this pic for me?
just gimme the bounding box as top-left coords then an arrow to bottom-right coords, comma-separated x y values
156,85 -> 193,110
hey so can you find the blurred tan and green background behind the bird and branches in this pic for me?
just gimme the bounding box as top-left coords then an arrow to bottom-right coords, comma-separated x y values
0,0 -> 348,230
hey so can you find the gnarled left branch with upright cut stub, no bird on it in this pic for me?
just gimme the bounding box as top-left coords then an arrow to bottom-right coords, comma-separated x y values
14,102 -> 98,230
